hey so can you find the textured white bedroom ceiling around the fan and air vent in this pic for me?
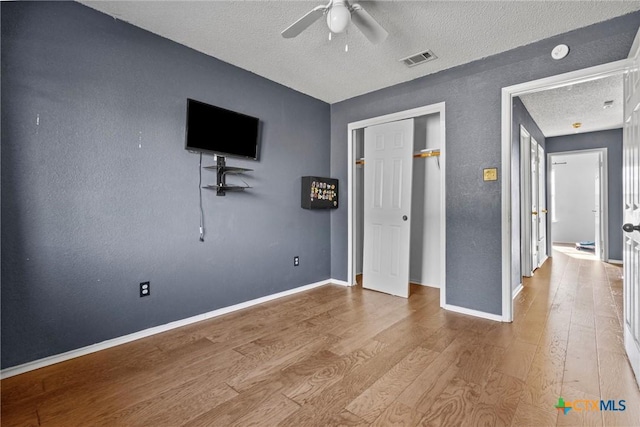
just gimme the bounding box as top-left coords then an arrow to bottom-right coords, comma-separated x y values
81,0 -> 640,103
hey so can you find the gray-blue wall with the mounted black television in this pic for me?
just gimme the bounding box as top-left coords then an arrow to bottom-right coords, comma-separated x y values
0,2 -> 336,368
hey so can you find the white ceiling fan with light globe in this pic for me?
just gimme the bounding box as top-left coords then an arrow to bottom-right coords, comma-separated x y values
282,0 -> 389,44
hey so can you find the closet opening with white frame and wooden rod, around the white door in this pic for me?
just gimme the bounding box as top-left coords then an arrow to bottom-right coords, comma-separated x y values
349,104 -> 446,306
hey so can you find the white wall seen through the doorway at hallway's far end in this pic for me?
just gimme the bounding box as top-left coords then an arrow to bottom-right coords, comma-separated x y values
549,153 -> 599,243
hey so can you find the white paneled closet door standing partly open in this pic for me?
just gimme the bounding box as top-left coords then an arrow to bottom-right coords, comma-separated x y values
362,119 -> 414,298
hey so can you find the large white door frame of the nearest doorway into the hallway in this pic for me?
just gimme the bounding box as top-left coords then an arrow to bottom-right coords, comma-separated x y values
501,59 -> 632,322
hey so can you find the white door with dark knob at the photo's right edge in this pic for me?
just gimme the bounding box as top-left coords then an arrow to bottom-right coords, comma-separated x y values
622,31 -> 640,385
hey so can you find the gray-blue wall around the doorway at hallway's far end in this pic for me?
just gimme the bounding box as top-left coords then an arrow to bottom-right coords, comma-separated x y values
547,129 -> 623,260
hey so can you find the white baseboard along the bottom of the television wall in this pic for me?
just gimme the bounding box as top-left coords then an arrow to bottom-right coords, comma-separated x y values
0,279 -> 336,379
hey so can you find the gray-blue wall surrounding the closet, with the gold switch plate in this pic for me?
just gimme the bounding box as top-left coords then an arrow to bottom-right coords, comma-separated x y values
331,13 -> 640,314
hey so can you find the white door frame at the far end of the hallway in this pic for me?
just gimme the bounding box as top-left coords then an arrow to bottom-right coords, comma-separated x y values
547,147 -> 609,262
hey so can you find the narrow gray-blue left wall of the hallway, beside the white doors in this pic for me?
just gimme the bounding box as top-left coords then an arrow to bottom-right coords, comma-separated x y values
511,97 -> 551,291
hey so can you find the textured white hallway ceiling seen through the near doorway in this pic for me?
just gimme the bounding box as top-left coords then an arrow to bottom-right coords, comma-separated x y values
520,75 -> 623,137
